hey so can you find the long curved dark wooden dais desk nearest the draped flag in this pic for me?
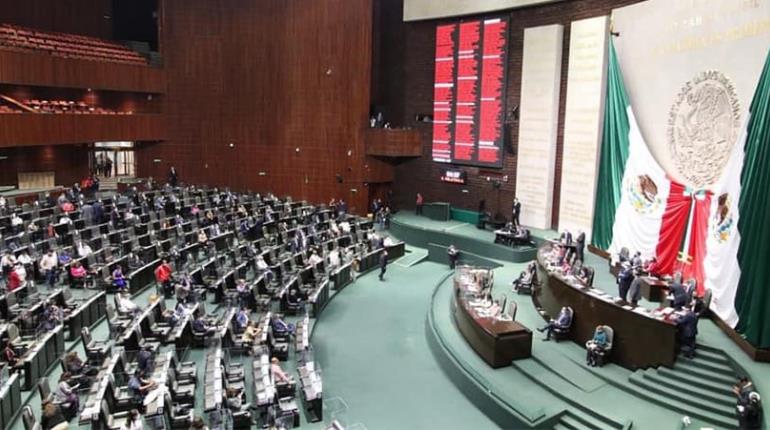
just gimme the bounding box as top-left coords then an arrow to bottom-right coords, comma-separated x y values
532,244 -> 676,369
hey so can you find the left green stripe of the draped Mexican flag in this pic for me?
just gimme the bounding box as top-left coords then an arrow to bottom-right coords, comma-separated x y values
591,38 -> 630,249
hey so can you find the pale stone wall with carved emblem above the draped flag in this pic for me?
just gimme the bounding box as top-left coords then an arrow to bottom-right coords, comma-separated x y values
613,0 -> 770,188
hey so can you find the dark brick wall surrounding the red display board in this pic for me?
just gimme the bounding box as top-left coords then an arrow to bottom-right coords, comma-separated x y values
372,0 -> 639,226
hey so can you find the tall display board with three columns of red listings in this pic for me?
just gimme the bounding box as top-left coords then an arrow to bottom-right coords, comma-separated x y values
432,18 -> 508,167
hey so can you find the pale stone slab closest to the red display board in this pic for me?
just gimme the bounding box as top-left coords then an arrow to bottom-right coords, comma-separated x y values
516,24 -> 564,229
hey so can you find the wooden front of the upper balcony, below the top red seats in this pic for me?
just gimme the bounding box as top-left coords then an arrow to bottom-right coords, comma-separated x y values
0,49 -> 166,93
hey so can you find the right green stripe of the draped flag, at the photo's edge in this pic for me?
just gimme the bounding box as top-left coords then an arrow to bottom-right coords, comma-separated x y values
735,48 -> 770,348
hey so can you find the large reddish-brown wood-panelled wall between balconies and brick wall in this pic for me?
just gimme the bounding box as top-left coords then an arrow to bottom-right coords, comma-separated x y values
138,0 -> 372,212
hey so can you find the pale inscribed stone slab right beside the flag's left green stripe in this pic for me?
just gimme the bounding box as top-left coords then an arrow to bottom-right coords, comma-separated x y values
559,16 -> 609,237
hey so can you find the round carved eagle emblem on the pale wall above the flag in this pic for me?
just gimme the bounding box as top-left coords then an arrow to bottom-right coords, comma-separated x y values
668,70 -> 740,188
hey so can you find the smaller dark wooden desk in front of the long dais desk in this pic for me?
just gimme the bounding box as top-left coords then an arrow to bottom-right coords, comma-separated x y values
454,280 -> 532,369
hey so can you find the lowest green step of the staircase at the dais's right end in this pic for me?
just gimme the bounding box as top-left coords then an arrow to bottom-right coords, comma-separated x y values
629,372 -> 736,428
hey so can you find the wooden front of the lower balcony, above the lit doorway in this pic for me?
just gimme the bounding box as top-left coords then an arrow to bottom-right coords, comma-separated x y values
0,114 -> 166,147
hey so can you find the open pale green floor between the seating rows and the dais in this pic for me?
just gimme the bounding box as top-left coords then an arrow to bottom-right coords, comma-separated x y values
313,263 -> 496,430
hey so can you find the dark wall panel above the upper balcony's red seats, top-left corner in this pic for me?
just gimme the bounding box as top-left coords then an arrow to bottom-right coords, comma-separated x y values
0,0 -> 112,39
